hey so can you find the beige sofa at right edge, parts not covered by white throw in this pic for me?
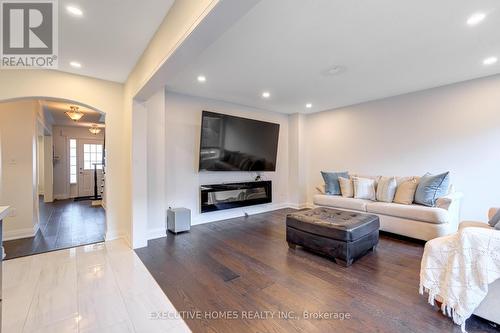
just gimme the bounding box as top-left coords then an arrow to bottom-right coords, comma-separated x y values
459,208 -> 500,325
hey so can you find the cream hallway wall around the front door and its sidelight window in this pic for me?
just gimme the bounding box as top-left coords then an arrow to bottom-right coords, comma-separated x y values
52,126 -> 105,200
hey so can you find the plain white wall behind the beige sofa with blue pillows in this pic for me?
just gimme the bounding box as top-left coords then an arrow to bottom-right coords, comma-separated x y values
305,76 -> 500,220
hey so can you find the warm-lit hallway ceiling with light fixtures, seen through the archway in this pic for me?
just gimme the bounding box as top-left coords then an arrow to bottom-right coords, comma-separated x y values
40,100 -> 105,127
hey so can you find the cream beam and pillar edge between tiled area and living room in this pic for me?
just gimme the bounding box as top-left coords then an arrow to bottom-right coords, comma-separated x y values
125,0 -> 219,248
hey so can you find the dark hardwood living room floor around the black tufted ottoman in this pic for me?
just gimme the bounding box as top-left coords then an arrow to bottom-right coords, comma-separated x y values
136,209 -> 496,333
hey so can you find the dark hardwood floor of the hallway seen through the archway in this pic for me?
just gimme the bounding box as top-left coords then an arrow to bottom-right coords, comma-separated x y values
3,200 -> 106,260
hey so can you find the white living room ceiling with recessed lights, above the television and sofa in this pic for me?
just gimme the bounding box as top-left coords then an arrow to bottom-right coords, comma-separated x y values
167,0 -> 500,113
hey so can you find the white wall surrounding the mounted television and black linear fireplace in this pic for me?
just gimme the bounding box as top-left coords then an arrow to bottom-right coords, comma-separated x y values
141,92 -> 289,237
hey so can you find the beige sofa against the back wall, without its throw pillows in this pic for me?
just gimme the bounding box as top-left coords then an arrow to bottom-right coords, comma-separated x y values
313,180 -> 462,241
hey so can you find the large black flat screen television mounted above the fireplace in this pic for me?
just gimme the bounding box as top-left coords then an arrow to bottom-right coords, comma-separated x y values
200,111 -> 280,171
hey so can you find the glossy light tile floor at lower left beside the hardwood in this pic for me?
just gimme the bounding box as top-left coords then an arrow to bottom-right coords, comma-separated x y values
2,240 -> 190,333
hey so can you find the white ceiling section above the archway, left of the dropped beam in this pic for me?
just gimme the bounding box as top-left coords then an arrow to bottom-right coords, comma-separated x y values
59,0 -> 174,82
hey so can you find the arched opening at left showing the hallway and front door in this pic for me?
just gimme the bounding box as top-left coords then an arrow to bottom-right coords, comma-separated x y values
0,96 -> 108,258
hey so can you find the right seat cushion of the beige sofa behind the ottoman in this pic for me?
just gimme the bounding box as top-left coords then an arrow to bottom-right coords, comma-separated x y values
366,202 -> 450,224
